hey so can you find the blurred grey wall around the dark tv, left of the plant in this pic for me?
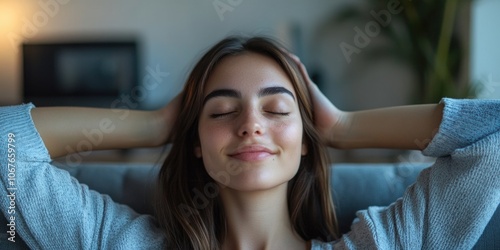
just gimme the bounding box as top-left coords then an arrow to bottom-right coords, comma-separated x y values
0,0 -> 339,108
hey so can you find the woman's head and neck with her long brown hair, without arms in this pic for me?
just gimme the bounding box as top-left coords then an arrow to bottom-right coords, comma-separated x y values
156,38 -> 342,249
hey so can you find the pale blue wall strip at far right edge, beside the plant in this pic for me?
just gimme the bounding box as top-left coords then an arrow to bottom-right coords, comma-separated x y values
471,0 -> 500,99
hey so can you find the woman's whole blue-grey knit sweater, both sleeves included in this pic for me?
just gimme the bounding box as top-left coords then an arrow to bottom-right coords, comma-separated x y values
0,99 -> 500,249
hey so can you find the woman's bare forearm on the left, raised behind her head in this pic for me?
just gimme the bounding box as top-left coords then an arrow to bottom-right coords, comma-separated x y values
31,96 -> 180,158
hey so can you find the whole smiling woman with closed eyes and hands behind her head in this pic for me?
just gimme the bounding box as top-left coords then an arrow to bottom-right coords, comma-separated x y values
0,38 -> 500,249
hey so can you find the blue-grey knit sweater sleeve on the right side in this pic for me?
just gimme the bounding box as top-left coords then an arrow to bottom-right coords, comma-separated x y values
335,99 -> 500,249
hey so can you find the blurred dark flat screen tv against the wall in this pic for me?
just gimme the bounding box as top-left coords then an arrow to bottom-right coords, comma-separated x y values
22,41 -> 138,107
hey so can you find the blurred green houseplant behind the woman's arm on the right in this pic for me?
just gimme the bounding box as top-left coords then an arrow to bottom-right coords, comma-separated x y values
328,0 -> 474,103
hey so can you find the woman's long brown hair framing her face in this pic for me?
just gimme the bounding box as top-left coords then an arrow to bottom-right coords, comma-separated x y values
155,37 -> 338,249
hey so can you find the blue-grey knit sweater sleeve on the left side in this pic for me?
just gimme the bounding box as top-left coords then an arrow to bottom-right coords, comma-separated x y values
0,104 -> 165,249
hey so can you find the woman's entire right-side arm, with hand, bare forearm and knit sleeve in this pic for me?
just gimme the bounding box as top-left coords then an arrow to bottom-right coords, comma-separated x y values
290,51 -> 500,249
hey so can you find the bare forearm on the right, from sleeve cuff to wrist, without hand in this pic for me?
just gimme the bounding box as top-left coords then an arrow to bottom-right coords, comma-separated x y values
329,104 -> 443,150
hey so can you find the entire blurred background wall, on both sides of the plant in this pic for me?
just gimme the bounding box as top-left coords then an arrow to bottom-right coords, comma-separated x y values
0,0 -> 500,109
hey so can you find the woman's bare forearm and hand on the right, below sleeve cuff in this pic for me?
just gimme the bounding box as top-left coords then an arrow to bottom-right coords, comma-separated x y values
291,52 -> 443,150
